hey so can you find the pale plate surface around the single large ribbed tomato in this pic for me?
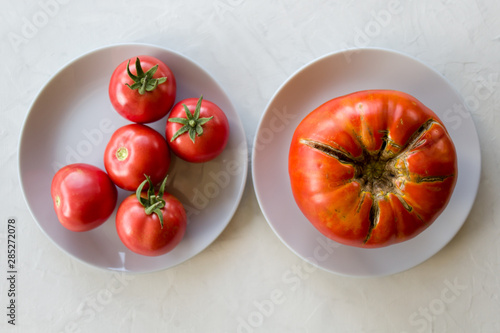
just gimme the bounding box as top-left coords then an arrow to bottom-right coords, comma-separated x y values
252,48 -> 481,276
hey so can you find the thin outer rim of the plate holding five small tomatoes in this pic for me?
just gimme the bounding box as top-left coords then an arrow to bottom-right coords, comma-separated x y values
16,42 -> 249,274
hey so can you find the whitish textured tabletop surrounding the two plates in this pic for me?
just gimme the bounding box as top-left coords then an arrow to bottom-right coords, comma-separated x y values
0,0 -> 500,333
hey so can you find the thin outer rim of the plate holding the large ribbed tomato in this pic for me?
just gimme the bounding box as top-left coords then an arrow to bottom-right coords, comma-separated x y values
251,47 -> 482,278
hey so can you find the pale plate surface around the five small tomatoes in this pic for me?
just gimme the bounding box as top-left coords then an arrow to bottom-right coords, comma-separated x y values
19,44 -> 248,272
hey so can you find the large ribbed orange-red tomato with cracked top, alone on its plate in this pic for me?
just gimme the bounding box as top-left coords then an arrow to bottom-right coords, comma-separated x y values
288,90 -> 457,248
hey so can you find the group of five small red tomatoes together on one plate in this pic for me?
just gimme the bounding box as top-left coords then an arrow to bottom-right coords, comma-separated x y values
51,55 -> 229,256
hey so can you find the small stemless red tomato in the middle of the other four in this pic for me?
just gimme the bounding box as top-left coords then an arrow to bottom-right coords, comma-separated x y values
104,124 -> 170,191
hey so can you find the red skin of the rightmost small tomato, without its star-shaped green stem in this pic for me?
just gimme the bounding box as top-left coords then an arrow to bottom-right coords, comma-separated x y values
165,98 -> 229,163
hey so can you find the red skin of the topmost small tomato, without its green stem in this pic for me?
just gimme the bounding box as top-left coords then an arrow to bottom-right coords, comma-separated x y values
108,55 -> 177,124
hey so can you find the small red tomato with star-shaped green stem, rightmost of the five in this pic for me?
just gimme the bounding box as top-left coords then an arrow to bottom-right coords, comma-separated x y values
165,96 -> 229,163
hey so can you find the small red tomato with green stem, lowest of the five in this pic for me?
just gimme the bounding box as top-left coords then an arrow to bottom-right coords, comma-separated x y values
116,178 -> 187,256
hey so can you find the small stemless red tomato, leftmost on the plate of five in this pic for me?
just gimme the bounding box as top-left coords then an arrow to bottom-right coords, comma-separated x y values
50,163 -> 117,231
